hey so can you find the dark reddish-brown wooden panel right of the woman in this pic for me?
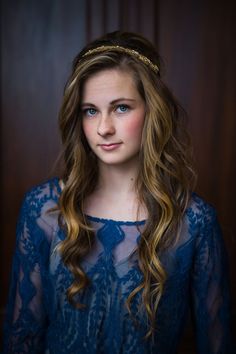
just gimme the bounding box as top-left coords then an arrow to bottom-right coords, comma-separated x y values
159,0 -> 236,315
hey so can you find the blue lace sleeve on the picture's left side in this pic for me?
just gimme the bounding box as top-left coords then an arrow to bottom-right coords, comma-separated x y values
3,197 -> 47,354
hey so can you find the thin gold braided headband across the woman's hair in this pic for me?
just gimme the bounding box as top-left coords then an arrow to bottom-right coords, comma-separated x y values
82,45 -> 159,73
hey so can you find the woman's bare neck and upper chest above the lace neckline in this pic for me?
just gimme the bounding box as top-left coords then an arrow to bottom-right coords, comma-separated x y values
84,162 -> 148,220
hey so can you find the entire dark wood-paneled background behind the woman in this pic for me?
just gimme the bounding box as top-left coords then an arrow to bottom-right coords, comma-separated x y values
0,0 -> 236,353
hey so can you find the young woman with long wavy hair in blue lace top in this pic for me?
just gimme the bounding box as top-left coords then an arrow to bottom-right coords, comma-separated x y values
2,32 -> 233,354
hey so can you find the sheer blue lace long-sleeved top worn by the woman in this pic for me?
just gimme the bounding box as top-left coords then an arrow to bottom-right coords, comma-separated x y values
4,178 -> 233,354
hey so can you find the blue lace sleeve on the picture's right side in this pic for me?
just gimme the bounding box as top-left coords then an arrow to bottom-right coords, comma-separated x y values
192,206 -> 233,354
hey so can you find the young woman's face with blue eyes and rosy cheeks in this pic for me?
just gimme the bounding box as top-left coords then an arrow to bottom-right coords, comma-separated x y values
81,69 -> 145,170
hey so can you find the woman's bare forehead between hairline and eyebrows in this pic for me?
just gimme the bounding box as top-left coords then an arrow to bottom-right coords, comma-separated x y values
82,69 -> 139,101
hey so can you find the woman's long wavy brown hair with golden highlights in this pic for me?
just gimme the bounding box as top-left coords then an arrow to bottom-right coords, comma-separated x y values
56,31 -> 195,338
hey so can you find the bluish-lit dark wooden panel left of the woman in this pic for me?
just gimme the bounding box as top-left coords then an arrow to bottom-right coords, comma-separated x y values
0,0 -> 86,318
